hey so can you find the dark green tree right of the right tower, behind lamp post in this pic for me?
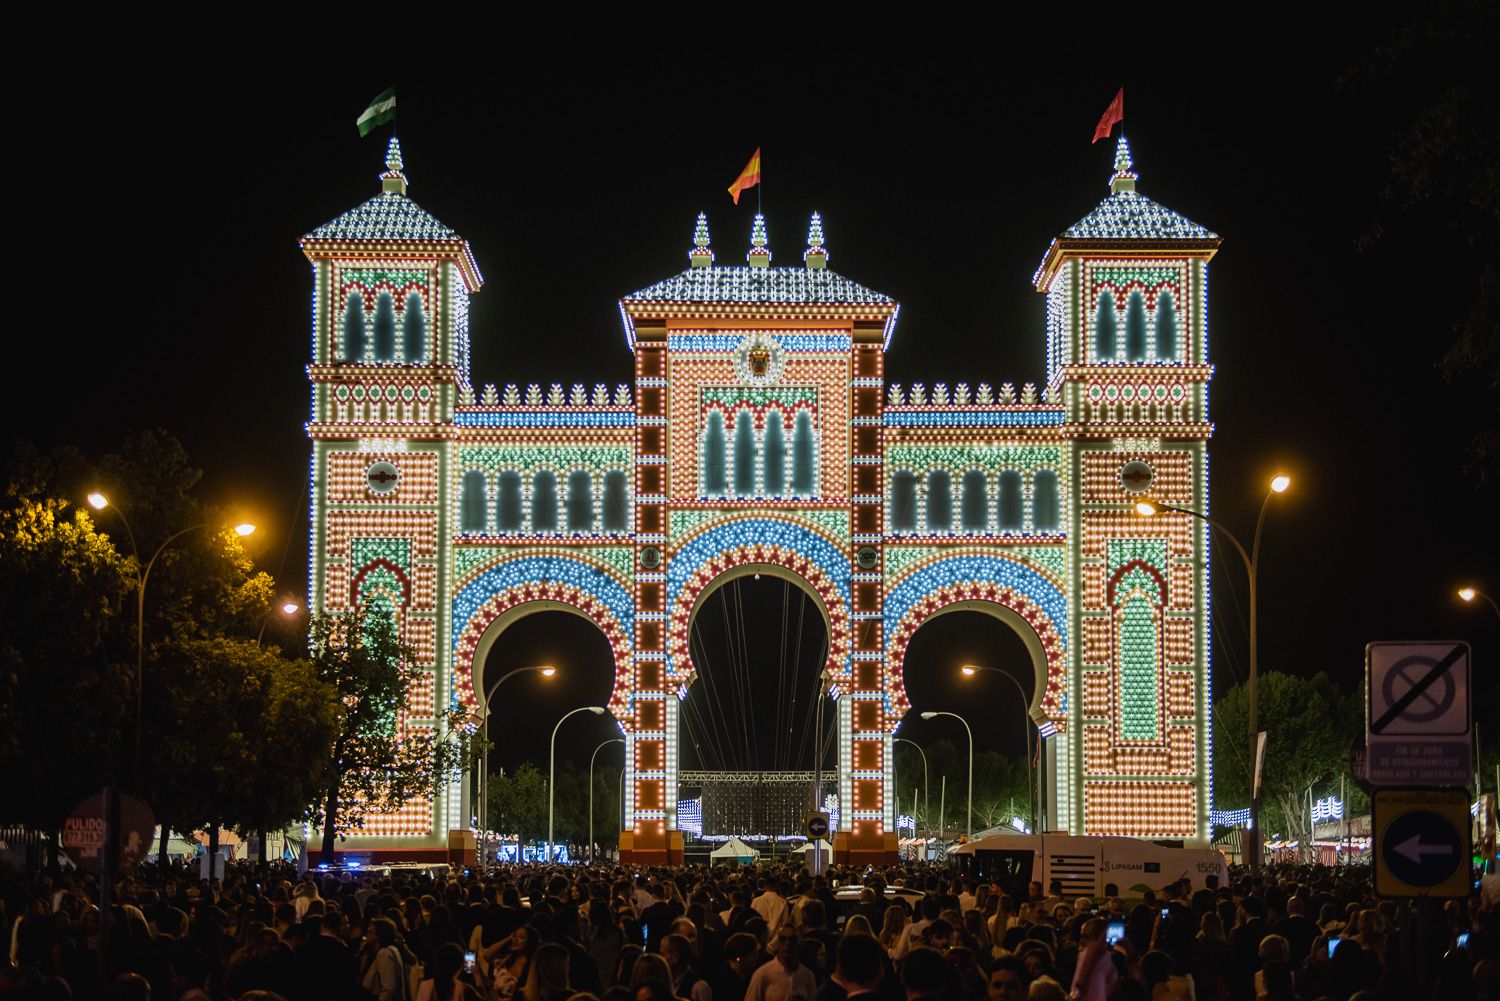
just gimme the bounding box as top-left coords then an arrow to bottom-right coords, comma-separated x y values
1214,671 -> 1362,836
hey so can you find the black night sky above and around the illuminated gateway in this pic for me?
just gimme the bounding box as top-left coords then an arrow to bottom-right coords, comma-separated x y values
9,29 -> 1500,780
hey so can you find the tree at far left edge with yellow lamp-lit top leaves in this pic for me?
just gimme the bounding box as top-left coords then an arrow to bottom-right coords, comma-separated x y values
0,498 -> 135,831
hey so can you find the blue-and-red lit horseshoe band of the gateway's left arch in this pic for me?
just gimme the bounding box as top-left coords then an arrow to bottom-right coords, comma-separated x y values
450,555 -> 636,725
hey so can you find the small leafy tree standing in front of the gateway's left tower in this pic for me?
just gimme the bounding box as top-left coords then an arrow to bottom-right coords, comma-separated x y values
311,609 -> 477,855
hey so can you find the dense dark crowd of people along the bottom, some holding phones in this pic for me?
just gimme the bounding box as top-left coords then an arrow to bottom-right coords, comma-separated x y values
0,864 -> 1500,1001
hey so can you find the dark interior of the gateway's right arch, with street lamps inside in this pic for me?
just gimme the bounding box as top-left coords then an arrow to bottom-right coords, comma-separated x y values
896,608 -> 1040,836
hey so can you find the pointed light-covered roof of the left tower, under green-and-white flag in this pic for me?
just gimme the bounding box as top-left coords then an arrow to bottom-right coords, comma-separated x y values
302,137 -> 485,291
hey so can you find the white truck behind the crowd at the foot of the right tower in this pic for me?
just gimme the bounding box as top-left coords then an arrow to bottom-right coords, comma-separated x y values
948,834 -> 1229,900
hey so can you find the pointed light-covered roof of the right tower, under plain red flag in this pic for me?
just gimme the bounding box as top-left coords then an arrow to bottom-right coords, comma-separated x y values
1034,135 -> 1221,288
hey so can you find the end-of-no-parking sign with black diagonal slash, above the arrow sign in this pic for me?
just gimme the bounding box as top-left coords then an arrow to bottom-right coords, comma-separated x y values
1365,641 -> 1475,786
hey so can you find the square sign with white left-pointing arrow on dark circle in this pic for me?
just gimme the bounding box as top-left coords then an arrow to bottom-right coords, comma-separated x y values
1373,789 -> 1470,897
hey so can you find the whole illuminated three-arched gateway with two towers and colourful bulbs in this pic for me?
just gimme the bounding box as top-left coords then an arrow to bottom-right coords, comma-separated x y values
302,138 -> 1220,863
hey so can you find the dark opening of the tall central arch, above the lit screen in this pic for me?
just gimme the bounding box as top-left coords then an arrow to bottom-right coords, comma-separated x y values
680,570 -> 837,788
